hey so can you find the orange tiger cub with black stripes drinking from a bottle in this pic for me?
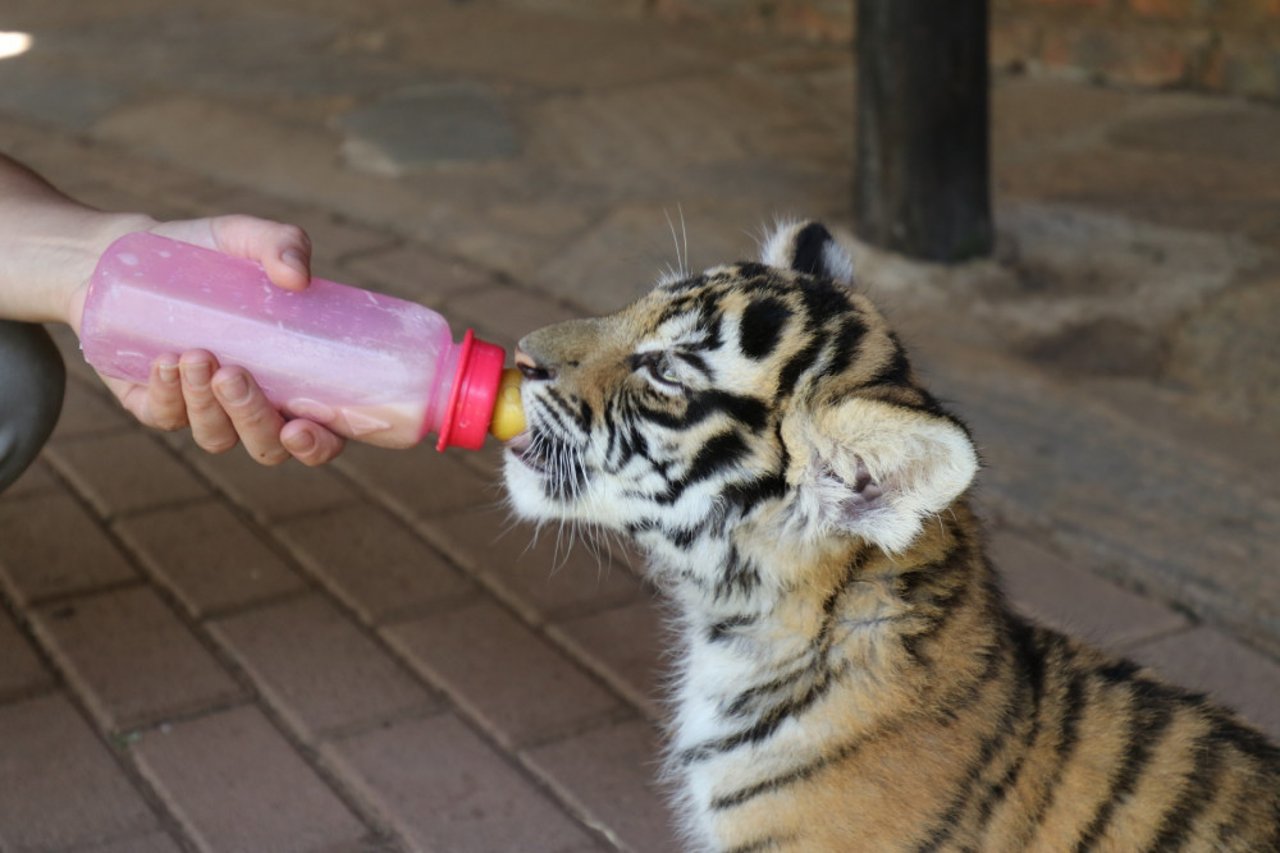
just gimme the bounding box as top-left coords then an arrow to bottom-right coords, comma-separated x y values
504,223 -> 1280,853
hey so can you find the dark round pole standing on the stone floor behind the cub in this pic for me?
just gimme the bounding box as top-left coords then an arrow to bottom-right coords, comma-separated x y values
854,0 -> 993,261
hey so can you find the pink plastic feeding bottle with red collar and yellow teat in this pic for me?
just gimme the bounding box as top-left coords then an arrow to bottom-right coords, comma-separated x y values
81,233 -> 522,451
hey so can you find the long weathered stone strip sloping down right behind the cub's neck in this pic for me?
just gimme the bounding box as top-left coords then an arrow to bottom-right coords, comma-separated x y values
919,343 -> 1280,651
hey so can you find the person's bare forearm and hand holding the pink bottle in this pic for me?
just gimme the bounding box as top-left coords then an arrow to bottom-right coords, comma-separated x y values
0,154 -> 343,465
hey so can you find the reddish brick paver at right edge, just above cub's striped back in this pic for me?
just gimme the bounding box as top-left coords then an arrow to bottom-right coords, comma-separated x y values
1126,625 -> 1280,739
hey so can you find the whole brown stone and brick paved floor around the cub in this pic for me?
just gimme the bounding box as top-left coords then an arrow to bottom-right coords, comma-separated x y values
0,0 -> 1280,853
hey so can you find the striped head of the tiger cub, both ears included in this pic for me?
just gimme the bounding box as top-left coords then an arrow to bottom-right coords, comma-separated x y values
504,223 -> 978,596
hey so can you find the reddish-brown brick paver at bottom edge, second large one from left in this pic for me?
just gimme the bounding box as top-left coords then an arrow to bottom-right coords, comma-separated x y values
133,707 -> 365,853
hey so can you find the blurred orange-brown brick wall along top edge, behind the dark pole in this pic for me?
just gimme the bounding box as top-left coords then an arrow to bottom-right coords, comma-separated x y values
645,0 -> 1280,100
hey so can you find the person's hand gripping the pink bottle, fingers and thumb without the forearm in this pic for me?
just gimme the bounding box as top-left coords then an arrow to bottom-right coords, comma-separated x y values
68,215 -> 344,465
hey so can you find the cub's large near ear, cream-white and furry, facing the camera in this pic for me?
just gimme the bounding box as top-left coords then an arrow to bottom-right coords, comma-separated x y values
799,398 -> 978,553
